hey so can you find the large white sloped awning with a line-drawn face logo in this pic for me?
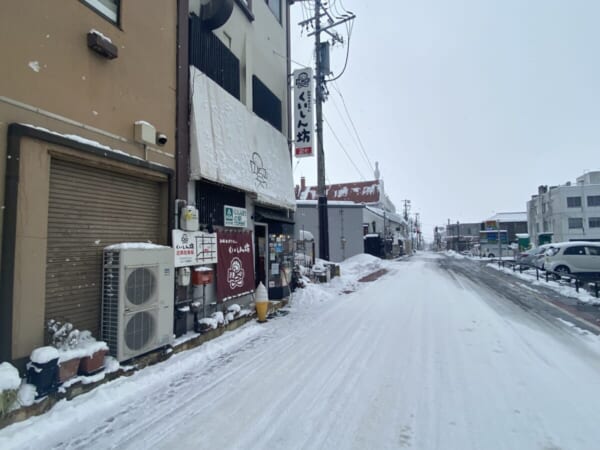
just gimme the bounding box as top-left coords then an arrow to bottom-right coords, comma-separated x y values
190,67 -> 296,209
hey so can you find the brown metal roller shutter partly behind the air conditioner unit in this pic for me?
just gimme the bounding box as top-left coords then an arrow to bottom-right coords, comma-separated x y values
45,158 -> 161,337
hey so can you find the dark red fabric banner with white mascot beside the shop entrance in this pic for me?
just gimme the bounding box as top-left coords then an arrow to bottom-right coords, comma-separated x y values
217,231 -> 254,302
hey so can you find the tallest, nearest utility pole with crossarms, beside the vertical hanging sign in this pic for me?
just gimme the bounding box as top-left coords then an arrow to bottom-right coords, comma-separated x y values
300,0 -> 356,261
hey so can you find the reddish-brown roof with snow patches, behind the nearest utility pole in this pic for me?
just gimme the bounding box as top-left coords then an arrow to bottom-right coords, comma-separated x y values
295,180 -> 382,204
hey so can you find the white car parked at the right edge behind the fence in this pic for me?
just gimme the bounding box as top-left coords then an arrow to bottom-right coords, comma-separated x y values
544,241 -> 600,273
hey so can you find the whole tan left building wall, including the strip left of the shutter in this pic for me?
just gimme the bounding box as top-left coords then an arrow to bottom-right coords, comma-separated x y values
0,0 -> 177,358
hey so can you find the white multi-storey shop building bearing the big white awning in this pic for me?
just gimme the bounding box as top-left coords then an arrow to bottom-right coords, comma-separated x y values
188,0 -> 295,302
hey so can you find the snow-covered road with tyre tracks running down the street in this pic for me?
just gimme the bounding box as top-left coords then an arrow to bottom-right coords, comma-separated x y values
0,255 -> 600,449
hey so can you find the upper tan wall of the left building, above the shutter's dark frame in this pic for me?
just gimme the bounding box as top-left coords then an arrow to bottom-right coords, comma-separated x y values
0,0 -> 177,255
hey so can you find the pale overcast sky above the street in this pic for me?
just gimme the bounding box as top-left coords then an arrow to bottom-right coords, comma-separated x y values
292,0 -> 600,236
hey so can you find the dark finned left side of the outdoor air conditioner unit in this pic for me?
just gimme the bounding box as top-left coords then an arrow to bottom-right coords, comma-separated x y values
102,251 -> 121,356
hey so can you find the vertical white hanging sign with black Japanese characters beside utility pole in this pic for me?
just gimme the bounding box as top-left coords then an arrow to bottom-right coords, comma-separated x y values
293,68 -> 314,158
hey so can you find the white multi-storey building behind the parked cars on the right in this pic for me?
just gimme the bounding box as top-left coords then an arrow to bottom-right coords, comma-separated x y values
527,171 -> 600,245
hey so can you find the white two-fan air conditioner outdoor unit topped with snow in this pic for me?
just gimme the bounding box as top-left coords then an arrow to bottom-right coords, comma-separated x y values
102,244 -> 174,362
